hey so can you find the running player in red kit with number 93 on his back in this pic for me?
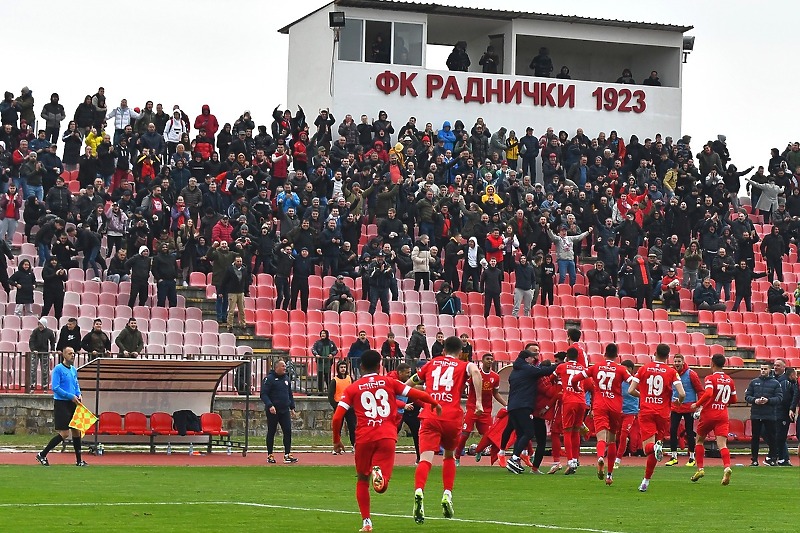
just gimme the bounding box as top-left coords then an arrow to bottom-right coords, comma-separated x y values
331,350 -> 442,531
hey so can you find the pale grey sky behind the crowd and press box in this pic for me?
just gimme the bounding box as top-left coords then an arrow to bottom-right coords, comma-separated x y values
0,0 -> 800,169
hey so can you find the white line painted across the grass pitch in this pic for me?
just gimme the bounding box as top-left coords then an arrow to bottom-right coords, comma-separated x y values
0,501 -> 624,533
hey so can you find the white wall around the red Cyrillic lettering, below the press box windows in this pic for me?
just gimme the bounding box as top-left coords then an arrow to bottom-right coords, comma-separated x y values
332,63 -> 681,142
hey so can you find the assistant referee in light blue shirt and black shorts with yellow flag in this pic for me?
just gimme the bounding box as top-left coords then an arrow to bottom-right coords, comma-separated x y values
36,347 -> 88,466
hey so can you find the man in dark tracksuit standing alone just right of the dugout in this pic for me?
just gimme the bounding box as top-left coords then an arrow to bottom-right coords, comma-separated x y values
261,360 -> 297,464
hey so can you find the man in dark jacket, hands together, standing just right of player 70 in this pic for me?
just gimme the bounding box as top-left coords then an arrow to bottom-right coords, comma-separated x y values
744,364 -> 783,466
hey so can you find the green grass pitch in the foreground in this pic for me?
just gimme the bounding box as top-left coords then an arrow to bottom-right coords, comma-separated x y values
0,457 -> 798,533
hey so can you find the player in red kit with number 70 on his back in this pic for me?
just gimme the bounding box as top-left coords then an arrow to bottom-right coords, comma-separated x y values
692,354 -> 737,485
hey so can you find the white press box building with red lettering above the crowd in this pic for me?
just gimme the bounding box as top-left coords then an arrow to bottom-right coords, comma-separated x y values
279,0 -> 693,141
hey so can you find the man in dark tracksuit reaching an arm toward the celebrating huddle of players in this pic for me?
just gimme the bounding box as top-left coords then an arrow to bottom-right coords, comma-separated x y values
506,345 -> 556,474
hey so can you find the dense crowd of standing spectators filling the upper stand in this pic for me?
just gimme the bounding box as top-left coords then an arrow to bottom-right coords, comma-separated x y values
0,83 -> 800,327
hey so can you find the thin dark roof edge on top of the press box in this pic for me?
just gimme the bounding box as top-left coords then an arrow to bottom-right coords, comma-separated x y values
278,0 -> 694,34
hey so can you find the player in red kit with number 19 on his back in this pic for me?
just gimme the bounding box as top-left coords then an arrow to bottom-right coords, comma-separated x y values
628,344 -> 686,492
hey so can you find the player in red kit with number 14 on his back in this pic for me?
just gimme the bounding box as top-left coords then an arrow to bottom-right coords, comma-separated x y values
406,337 -> 483,524
